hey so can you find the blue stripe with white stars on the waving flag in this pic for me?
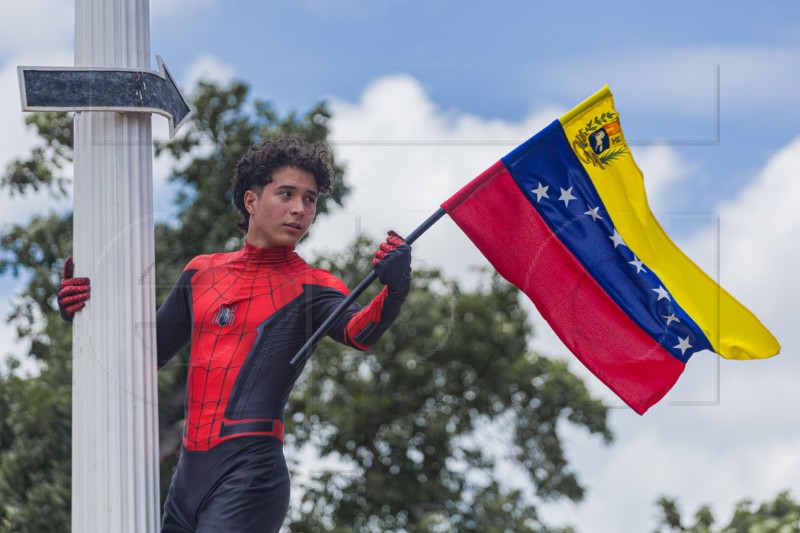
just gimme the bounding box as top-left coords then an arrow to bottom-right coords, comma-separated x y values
502,120 -> 711,362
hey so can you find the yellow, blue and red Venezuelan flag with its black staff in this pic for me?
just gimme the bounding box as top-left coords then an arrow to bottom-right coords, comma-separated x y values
292,86 -> 780,414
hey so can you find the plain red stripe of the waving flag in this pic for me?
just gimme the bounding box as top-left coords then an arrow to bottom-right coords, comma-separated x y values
442,161 -> 685,414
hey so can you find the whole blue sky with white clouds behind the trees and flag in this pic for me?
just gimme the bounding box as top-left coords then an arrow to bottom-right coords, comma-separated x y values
0,0 -> 800,533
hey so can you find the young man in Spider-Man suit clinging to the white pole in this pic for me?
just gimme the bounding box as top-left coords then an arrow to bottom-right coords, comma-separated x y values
59,138 -> 411,532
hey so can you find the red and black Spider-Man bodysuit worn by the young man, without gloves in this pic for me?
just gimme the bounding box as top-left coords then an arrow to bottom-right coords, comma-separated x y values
157,244 -> 405,531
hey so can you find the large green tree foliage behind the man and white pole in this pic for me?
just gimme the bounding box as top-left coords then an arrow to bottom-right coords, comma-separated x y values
0,77 -> 611,532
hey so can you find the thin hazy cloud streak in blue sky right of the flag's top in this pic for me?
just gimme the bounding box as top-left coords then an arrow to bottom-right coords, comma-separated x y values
536,45 -> 800,119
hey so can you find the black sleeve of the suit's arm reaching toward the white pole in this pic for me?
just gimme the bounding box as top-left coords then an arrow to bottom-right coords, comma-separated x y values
156,270 -> 197,368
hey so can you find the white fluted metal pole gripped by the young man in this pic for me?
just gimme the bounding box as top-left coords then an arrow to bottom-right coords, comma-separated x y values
72,0 -> 160,533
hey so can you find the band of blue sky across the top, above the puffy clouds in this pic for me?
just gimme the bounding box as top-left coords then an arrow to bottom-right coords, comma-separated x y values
152,1 -> 800,214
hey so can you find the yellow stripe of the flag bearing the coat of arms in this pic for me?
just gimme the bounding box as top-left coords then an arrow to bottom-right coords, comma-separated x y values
560,86 -> 780,359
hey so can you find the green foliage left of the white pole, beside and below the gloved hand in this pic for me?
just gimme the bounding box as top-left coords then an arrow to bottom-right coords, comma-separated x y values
0,182 -> 72,533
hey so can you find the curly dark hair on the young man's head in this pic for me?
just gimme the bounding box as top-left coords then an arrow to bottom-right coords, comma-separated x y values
233,137 -> 334,233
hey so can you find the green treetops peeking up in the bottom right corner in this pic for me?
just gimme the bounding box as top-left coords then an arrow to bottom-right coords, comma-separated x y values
656,491 -> 800,533
